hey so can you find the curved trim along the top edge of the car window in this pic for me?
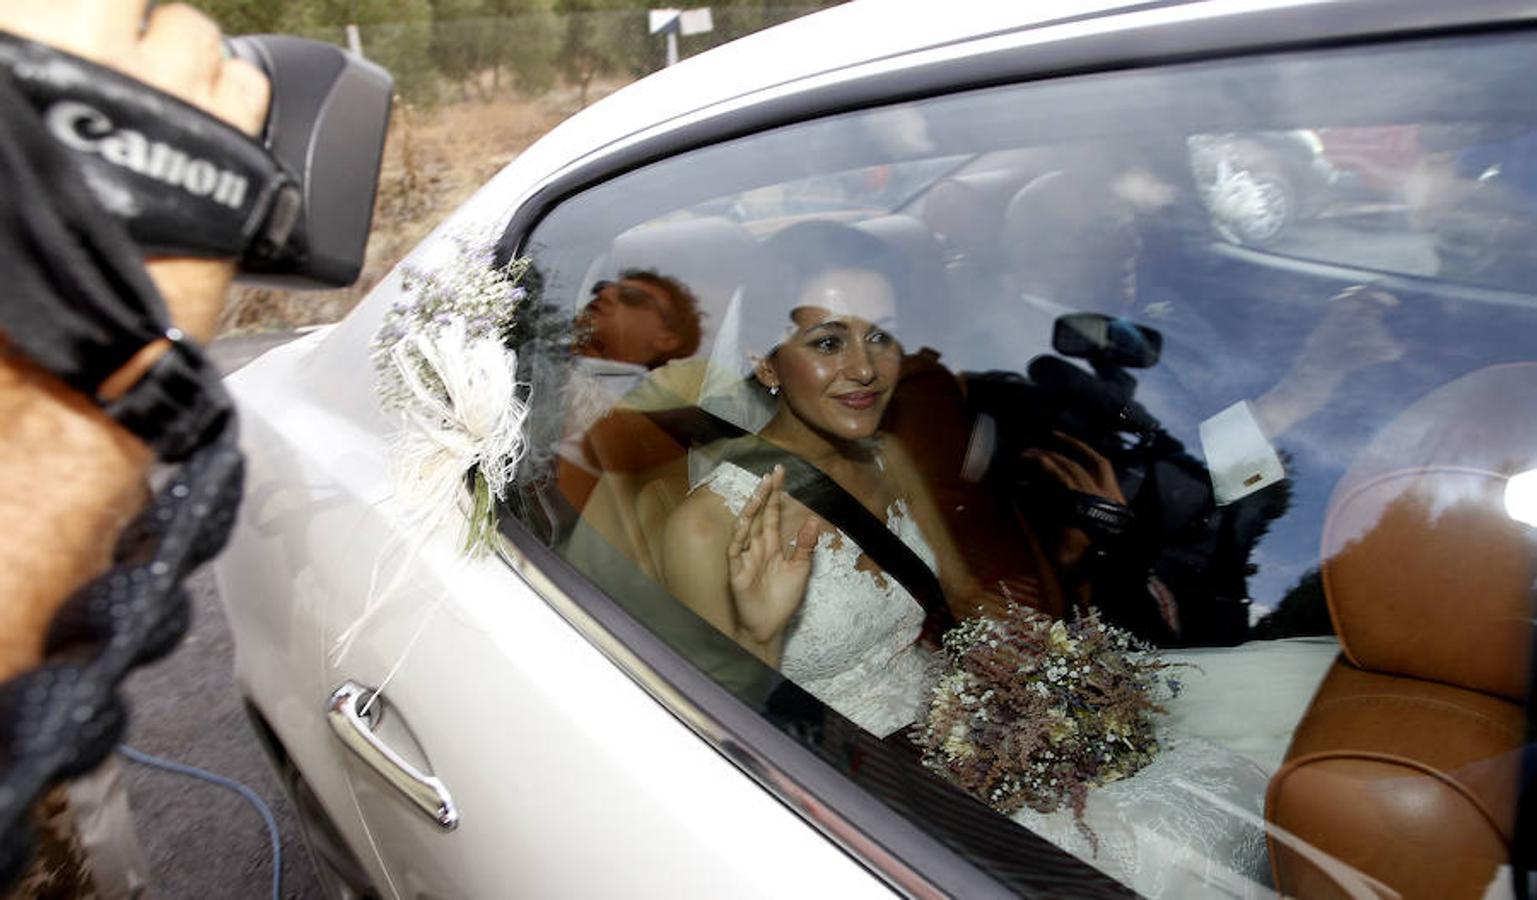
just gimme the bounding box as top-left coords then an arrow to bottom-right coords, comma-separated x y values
496,0 -> 1537,263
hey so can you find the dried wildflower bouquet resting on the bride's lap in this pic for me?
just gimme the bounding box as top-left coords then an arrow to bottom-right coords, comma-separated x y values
913,604 -> 1179,825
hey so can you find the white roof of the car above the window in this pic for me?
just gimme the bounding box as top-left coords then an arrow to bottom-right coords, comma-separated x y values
504,0 -> 1534,215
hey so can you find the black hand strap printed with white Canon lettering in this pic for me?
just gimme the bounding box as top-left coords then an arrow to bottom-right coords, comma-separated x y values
0,32 -> 301,260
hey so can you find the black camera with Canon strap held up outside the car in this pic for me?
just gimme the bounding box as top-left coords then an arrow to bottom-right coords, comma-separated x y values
0,34 -> 393,289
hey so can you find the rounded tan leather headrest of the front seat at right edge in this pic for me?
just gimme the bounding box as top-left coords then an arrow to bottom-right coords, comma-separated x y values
1322,362 -> 1537,700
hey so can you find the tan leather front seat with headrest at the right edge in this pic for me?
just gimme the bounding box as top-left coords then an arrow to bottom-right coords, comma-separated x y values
1266,364 -> 1537,898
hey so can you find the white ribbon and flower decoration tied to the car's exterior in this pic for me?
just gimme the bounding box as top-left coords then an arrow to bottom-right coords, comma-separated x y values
373,237 -> 529,554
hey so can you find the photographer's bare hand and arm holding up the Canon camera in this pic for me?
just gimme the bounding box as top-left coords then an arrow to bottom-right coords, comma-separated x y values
0,0 -> 267,679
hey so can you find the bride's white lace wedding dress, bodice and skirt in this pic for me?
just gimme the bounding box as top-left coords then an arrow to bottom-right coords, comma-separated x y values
702,462 -> 1339,897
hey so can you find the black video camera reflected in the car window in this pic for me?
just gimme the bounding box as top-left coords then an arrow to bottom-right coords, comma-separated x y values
967,313 -> 1266,647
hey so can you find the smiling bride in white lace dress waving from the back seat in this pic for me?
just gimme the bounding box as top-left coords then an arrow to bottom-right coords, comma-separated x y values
662,223 -> 1266,895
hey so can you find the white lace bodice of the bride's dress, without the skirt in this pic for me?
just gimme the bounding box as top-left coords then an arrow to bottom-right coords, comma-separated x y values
704,462 -> 936,737
